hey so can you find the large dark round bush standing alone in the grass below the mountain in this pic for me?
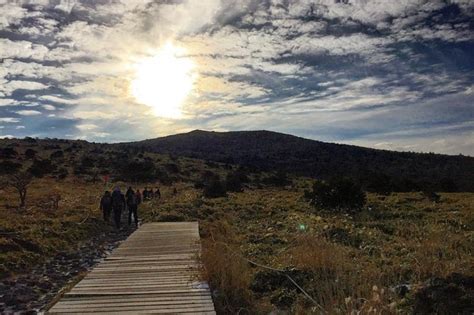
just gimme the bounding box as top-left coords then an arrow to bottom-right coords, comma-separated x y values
306,178 -> 366,210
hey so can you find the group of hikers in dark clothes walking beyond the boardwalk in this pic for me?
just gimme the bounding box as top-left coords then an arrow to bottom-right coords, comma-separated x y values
100,186 -> 161,229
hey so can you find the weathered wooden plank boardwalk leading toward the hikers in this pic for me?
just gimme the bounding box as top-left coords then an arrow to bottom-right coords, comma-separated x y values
48,222 -> 215,314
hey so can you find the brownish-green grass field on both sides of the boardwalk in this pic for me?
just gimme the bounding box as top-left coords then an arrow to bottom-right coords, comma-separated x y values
0,178 -> 474,314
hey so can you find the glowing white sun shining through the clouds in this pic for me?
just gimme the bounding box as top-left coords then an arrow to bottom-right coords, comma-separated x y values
131,43 -> 196,118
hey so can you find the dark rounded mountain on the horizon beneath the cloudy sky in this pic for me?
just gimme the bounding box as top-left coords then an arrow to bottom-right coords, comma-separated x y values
121,130 -> 474,191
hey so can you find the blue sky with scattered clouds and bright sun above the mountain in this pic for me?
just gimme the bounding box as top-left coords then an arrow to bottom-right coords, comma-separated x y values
0,0 -> 474,156
